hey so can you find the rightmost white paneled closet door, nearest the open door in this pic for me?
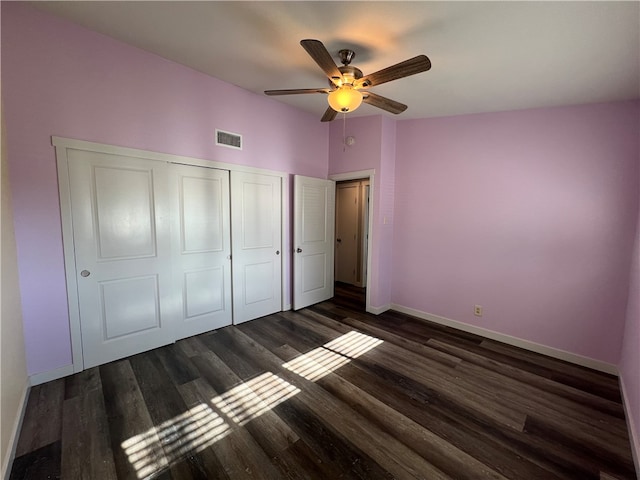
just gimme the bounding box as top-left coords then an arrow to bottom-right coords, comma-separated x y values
231,172 -> 282,324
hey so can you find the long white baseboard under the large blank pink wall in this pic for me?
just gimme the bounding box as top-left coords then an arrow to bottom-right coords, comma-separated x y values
391,304 -> 618,376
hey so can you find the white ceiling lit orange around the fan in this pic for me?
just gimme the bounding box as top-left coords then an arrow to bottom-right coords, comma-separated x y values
33,1 -> 640,119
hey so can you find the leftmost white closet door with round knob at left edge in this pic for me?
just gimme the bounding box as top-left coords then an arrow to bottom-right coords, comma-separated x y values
68,150 -> 177,368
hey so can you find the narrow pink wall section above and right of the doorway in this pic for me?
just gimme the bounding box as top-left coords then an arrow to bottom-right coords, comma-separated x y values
329,115 -> 395,307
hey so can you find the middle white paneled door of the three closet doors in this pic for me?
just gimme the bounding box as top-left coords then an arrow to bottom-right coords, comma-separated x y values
171,165 -> 232,339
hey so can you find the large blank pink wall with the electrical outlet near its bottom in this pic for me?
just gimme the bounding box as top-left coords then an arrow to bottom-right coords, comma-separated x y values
392,102 -> 640,364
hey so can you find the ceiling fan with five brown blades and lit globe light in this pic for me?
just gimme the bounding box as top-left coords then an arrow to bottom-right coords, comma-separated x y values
264,39 -> 431,122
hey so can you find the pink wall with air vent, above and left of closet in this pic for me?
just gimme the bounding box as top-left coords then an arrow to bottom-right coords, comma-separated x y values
1,2 -> 328,374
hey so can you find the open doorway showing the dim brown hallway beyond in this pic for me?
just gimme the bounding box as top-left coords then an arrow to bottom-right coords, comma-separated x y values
334,177 -> 370,311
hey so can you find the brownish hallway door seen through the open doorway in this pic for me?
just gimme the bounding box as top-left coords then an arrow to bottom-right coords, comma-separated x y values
335,183 -> 360,285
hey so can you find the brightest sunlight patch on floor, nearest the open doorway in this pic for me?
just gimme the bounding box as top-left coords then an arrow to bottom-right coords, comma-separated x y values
282,331 -> 383,382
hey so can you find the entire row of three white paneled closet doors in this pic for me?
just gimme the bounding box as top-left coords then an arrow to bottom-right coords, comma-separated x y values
65,144 -> 282,368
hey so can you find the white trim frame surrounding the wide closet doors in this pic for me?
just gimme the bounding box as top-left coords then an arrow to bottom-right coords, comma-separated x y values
51,136 -> 291,373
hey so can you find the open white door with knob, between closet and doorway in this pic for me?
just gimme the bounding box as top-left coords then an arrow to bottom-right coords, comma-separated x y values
293,175 -> 336,310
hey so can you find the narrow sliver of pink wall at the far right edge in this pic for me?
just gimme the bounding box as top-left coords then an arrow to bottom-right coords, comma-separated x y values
619,165 -> 640,464
